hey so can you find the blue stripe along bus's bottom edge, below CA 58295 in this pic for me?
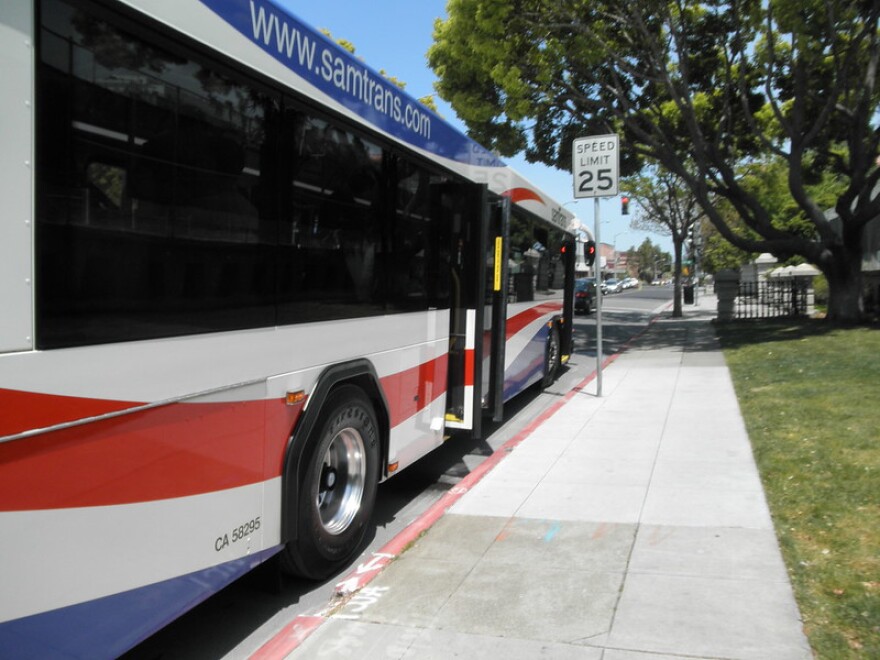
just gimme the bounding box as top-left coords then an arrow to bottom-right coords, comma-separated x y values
0,546 -> 281,660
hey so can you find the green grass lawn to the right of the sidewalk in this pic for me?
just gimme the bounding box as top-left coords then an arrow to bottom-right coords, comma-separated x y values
718,321 -> 880,659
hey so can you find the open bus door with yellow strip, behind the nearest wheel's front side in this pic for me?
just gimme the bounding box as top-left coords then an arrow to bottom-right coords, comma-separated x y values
437,183 -> 509,438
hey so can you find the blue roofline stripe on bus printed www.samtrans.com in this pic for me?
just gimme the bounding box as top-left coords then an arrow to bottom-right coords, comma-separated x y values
201,0 -> 504,167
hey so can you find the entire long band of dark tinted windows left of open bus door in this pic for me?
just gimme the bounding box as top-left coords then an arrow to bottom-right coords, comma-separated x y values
36,0 -> 460,349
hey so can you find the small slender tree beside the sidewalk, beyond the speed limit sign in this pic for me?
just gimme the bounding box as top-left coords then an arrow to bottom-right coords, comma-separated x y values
626,167 -> 703,317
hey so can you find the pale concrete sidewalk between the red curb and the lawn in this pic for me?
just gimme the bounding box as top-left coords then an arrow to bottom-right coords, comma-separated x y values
287,295 -> 812,660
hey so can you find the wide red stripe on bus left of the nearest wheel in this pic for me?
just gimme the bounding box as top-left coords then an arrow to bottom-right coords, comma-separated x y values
0,399 -> 302,511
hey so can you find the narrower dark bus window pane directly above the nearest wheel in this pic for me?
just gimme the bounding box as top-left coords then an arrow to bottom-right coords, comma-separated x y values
278,114 -> 385,325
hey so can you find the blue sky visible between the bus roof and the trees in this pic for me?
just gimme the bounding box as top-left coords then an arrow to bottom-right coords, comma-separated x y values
276,0 -> 672,252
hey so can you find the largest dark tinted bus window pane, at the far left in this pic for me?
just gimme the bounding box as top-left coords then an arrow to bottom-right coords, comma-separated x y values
36,1 -> 279,348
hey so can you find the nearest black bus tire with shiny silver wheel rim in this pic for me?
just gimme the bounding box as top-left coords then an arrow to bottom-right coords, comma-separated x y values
281,385 -> 379,580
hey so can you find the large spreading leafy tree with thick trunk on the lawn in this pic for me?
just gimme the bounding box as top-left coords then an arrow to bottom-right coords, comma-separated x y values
428,0 -> 880,321
